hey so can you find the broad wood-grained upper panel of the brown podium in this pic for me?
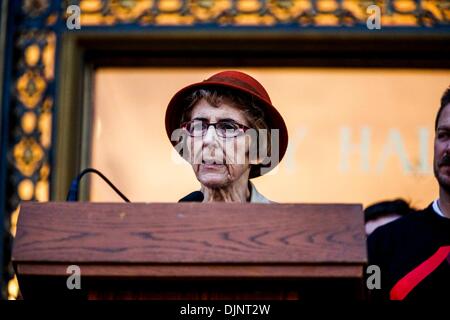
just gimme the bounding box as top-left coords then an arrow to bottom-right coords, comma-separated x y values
13,202 -> 366,265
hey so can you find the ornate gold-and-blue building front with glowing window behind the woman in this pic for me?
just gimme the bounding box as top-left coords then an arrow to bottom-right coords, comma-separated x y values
0,0 -> 450,299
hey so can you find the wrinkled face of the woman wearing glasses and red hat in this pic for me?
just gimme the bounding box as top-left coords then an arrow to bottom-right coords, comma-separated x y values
187,99 -> 250,188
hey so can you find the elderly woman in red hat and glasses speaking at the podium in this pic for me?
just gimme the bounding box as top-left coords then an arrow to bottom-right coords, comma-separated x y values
165,71 -> 288,203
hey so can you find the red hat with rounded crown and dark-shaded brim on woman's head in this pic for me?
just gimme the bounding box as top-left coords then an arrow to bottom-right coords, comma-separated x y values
165,71 -> 288,178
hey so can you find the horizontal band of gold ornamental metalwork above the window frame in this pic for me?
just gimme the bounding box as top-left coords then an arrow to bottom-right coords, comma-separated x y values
75,0 -> 450,27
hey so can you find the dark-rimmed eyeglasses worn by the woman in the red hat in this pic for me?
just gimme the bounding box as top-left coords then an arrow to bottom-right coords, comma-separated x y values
181,119 -> 250,138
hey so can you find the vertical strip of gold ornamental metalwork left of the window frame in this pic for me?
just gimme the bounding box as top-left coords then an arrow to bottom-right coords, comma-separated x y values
5,0 -> 58,299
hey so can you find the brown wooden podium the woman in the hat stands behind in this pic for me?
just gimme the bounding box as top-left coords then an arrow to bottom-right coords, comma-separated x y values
12,202 -> 366,300
